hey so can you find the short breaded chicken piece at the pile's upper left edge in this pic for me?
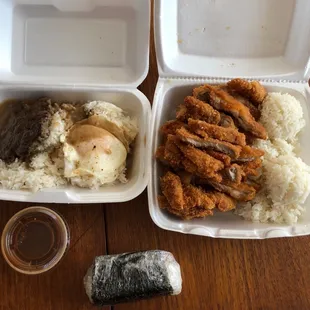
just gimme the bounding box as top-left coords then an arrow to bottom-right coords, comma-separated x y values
176,96 -> 221,124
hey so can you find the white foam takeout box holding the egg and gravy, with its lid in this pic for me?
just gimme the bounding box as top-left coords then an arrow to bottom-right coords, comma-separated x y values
0,0 -> 151,203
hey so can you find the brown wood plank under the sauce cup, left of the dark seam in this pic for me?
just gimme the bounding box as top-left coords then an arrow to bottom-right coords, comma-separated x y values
0,201 -> 109,310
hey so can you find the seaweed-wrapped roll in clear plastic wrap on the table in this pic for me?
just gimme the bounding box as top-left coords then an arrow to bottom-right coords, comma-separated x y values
84,250 -> 182,306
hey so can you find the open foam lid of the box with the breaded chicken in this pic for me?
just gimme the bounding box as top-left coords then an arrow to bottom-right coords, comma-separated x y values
155,0 -> 310,80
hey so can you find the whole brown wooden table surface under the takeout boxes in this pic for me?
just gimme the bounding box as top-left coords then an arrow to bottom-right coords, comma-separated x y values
0,3 -> 310,310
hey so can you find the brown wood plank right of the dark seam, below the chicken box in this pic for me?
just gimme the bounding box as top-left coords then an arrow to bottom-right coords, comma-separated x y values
106,192 -> 310,310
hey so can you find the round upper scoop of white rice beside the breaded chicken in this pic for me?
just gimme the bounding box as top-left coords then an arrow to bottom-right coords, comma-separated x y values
260,93 -> 305,143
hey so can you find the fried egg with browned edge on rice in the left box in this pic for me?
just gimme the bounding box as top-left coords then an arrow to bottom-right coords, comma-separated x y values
63,123 -> 127,188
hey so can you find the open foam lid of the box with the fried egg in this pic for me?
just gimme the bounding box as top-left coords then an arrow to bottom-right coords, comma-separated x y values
0,0 -> 150,87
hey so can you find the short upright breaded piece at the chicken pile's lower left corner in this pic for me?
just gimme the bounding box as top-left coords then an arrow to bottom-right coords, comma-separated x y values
160,171 -> 185,210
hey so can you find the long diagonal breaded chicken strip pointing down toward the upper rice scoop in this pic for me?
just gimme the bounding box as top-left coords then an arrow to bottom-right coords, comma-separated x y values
194,84 -> 267,139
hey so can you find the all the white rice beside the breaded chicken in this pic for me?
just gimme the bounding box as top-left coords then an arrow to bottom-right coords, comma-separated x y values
236,93 -> 310,224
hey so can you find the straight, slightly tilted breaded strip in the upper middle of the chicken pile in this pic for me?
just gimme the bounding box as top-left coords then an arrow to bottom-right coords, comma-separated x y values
188,118 -> 246,145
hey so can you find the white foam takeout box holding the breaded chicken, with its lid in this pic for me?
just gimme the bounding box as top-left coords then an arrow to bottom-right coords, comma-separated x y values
148,0 -> 310,239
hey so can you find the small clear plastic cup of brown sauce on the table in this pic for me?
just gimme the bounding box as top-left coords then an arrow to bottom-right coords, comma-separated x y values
1,206 -> 70,274
